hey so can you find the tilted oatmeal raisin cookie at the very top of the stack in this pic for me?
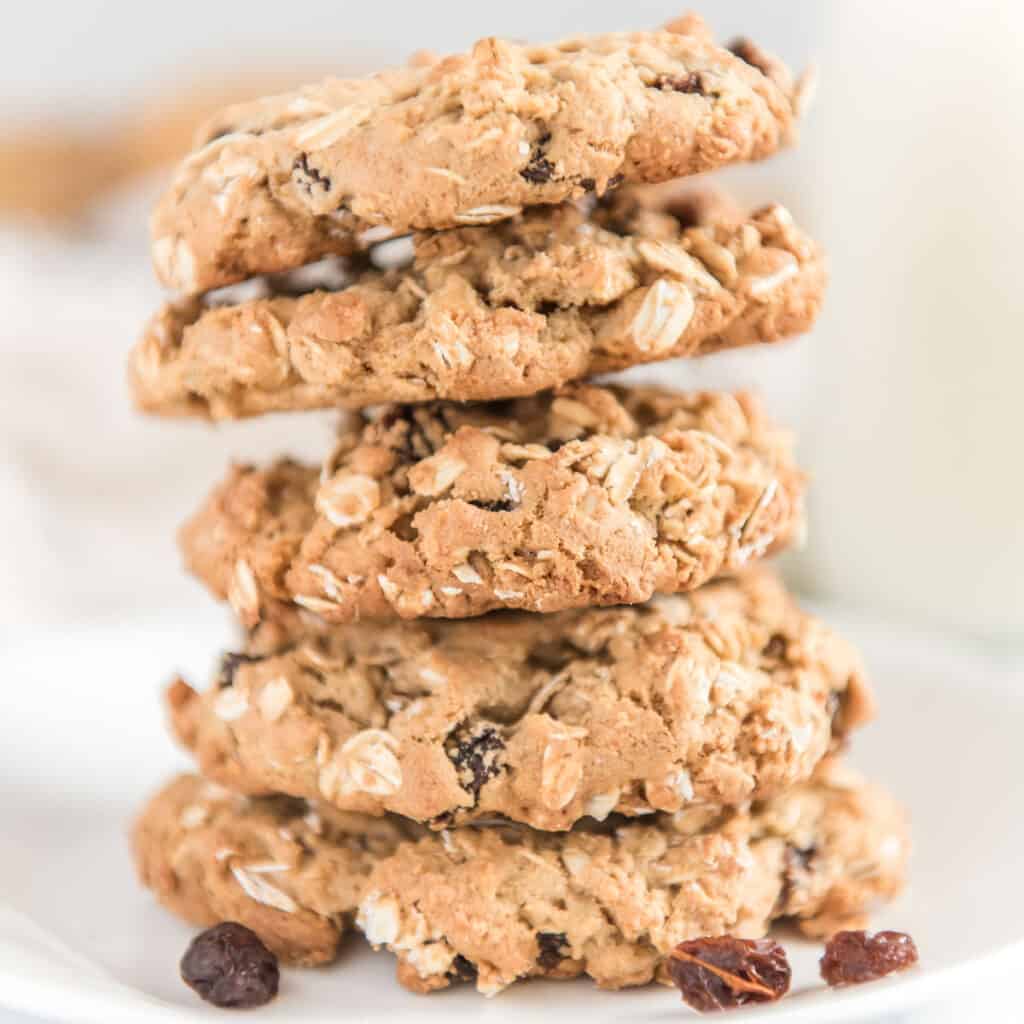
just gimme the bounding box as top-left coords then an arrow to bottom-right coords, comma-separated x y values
152,19 -> 802,293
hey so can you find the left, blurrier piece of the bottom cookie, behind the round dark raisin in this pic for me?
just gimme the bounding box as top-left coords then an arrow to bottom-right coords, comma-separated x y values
132,775 -> 417,964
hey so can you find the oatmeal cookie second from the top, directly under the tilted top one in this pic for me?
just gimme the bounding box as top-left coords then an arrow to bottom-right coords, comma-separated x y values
129,185 -> 825,419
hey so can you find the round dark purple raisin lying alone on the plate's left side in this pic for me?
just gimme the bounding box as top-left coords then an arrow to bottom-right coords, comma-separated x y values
181,921 -> 280,1008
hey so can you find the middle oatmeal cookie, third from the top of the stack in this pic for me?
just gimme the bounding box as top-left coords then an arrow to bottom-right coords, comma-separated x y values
180,386 -> 804,626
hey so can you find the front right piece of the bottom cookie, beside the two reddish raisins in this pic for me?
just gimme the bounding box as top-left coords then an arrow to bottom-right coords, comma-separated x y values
356,765 -> 908,995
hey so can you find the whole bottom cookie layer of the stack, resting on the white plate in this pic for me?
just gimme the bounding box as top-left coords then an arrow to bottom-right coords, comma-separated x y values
134,762 -> 908,994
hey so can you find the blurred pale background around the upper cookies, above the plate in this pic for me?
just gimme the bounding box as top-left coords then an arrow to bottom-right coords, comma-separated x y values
0,0 -> 1024,648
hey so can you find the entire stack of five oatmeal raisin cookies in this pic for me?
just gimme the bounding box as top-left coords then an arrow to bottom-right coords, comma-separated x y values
125,16 -> 906,994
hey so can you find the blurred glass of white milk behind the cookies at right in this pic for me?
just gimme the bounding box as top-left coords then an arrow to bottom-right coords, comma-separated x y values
648,0 -> 1024,649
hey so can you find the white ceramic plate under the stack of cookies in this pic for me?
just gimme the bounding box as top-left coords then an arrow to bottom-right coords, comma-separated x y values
0,622 -> 1024,1024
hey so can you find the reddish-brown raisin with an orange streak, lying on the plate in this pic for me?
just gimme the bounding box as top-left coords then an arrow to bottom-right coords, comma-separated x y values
668,935 -> 792,1012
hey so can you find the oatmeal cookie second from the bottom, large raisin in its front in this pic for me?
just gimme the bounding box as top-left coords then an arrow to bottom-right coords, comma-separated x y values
169,572 -> 872,829
